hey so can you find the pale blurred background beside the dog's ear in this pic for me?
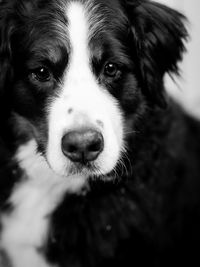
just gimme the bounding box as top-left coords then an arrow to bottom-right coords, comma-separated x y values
155,0 -> 200,117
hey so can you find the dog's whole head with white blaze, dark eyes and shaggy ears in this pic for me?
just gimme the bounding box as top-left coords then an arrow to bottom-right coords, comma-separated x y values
0,0 -> 186,180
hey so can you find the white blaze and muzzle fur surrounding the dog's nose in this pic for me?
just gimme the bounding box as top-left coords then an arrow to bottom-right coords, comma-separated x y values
47,2 -> 123,180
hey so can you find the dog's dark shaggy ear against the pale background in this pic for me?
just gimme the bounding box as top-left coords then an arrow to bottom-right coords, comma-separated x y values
125,0 -> 188,107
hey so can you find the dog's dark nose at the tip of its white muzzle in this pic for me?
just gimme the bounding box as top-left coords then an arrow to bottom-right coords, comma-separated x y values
62,129 -> 104,163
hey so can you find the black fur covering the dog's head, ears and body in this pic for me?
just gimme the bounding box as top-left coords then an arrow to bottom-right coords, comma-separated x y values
0,0 -> 200,267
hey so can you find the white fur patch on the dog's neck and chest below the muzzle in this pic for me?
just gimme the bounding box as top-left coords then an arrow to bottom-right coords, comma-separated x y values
1,140 -> 84,267
